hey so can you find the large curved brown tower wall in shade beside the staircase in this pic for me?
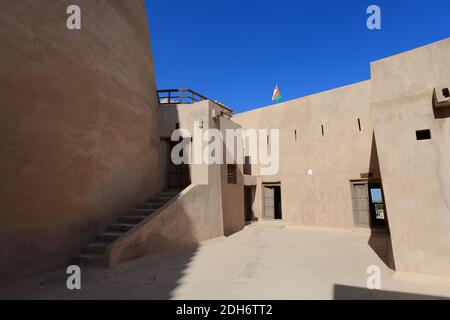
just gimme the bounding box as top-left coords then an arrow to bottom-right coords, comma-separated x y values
0,0 -> 159,281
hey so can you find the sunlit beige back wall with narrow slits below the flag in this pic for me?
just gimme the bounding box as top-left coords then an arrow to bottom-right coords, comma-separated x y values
233,81 -> 379,228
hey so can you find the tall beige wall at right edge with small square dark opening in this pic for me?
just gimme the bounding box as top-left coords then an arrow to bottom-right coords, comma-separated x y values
371,39 -> 450,276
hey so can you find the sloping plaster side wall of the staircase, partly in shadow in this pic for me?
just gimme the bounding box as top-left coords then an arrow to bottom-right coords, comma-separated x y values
107,165 -> 224,265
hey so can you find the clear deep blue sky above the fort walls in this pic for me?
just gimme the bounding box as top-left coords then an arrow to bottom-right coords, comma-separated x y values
147,0 -> 450,112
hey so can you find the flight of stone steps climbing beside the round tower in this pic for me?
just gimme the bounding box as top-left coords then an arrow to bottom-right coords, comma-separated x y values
75,189 -> 181,265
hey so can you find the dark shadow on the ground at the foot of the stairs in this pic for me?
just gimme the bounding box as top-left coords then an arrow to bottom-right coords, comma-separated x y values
0,246 -> 198,300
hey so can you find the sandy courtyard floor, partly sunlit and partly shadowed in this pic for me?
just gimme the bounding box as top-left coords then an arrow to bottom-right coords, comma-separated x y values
0,222 -> 450,299
